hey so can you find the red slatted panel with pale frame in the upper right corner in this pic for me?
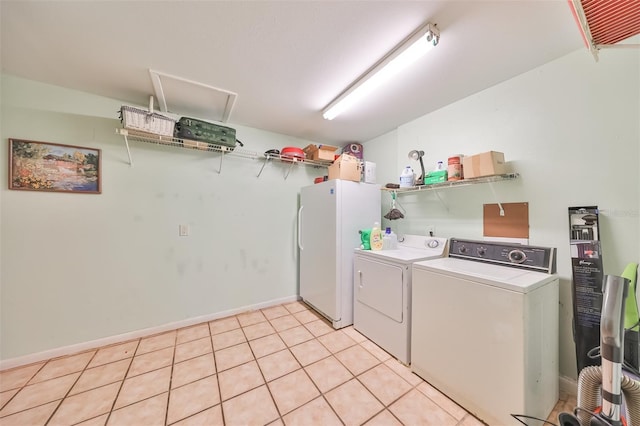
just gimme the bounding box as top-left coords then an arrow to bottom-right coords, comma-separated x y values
569,0 -> 640,60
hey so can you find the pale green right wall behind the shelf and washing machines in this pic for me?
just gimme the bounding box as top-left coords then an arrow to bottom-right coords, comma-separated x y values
364,49 -> 640,378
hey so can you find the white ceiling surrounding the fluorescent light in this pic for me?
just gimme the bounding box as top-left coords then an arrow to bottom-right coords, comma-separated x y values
0,0 -> 585,144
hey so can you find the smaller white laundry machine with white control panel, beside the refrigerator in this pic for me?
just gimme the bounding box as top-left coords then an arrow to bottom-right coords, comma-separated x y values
353,235 -> 447,364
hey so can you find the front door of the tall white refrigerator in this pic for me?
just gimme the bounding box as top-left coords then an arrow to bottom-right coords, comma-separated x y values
298,180 -> 341,321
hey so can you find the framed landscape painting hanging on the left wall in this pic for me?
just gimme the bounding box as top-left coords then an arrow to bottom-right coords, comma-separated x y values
9,139 -> 102,194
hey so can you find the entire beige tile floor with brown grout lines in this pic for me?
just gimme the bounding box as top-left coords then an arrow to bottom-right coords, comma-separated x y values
0,302 -> 567,426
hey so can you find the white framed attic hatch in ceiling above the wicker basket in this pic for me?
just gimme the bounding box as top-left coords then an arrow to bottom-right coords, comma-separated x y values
149,69 -> 238,123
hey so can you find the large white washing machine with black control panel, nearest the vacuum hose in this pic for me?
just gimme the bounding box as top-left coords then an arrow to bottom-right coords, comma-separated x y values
411,238 -> 559,425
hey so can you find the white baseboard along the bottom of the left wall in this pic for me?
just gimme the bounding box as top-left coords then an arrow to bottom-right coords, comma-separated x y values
0,296 -> 300,371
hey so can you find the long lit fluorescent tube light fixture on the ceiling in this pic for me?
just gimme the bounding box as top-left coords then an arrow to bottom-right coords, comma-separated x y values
322,23 -> 440,120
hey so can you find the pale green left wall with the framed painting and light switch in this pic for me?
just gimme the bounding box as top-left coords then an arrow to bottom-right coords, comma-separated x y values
0,75 -> 324,360
